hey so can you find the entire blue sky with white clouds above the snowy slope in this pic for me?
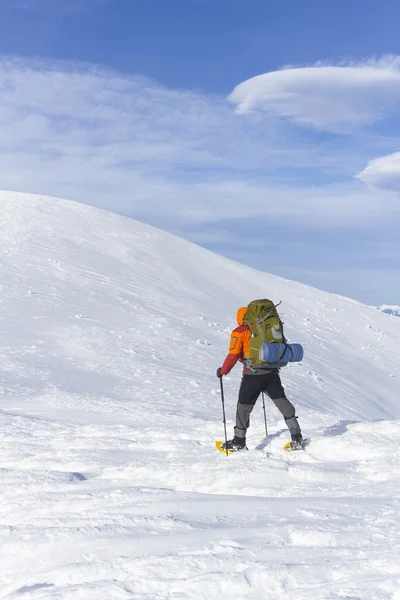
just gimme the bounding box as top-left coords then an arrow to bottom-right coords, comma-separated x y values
0,0 -> 400,304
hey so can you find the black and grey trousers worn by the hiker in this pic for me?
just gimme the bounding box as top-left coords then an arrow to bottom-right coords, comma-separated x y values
234,371 -> 301,439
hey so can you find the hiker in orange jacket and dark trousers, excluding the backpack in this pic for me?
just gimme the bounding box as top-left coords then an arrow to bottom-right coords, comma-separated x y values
217,301 -> 303,452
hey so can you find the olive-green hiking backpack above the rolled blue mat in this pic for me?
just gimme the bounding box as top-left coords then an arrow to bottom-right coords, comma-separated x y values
243,299 -> 286,367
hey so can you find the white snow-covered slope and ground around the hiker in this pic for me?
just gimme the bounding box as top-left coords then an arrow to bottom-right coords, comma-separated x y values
0,192 -> 400,600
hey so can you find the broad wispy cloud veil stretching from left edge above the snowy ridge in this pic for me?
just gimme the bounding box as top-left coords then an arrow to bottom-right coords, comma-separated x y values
0,60 -> 398,227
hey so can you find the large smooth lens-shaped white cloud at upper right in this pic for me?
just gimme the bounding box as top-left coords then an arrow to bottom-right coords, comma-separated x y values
229,56 -> 400,133
